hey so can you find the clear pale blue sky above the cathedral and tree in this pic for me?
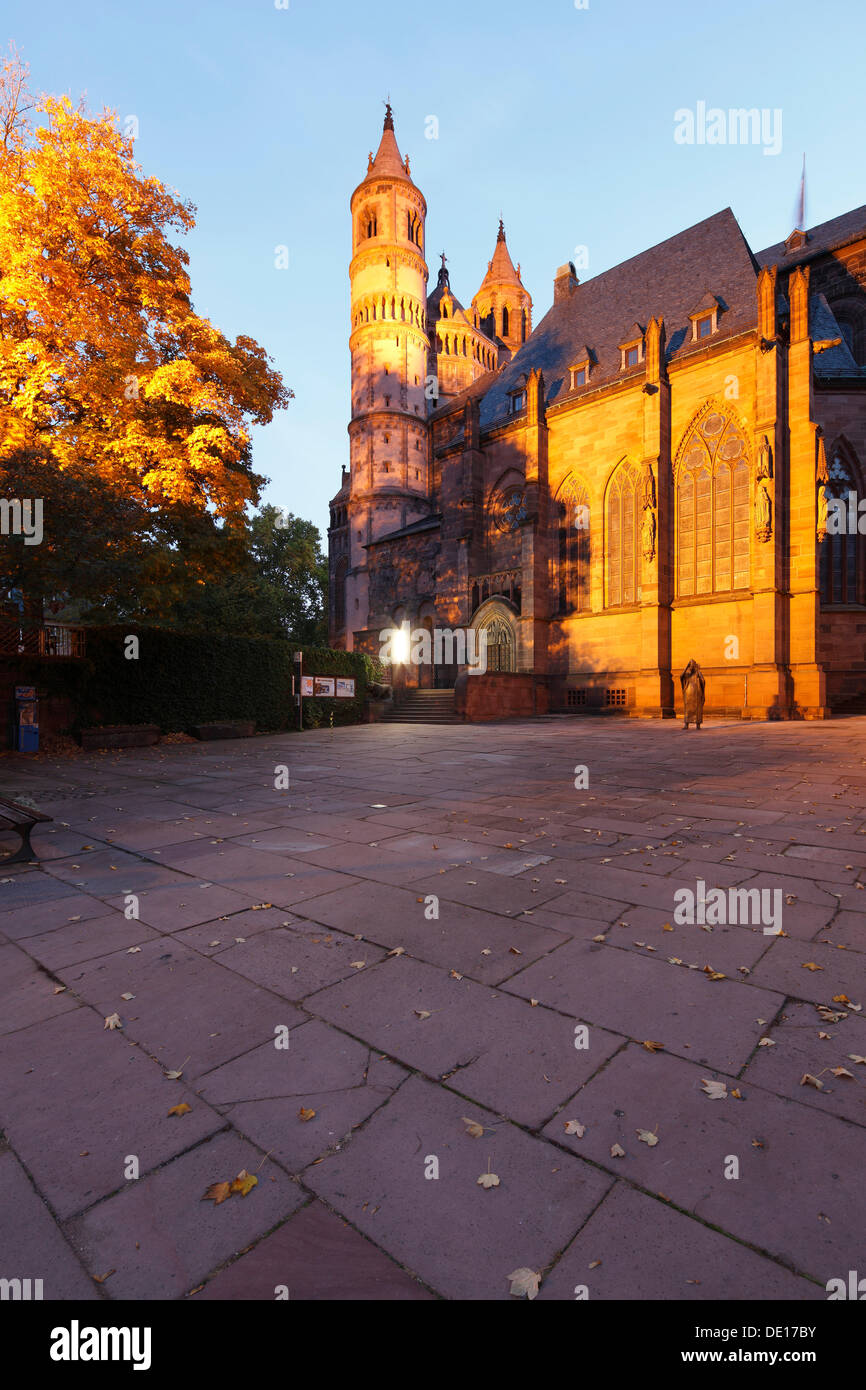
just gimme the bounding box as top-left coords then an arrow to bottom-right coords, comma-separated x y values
8,0 -> 866,531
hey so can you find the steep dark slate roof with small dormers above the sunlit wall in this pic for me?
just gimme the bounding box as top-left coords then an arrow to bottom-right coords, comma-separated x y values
481,207 -> 758,428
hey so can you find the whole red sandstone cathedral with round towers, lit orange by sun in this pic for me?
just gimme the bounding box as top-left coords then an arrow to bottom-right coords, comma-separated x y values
328,107 -> 866,719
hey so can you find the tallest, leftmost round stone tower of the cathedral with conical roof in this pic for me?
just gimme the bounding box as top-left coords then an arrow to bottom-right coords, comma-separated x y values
340,106 -> 430,651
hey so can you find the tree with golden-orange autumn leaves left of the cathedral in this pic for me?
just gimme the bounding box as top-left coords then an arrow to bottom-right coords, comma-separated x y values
0,54 -> 292,611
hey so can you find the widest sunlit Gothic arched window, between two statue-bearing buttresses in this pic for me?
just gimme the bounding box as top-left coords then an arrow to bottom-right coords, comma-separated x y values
677,410 -> 751,598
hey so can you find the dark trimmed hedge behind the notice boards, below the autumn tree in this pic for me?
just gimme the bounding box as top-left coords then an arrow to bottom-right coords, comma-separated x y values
1,624 -> 381,734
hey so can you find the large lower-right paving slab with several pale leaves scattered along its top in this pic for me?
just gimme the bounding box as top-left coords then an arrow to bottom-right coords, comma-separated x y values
545,1045 -> 865,1286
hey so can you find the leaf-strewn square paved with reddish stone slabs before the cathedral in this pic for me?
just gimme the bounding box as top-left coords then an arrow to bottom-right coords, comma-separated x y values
0,717 -> 866,1304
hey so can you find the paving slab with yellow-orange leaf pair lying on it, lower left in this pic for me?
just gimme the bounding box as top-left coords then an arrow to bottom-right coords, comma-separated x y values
65,1134 -> 303,1300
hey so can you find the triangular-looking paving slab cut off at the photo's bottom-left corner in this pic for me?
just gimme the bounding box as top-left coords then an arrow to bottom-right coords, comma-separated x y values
0,1148 -> 99,1301
